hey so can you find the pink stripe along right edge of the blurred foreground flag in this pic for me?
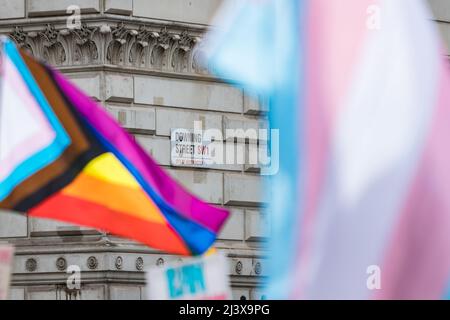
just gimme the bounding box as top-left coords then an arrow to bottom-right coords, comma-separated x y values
374,63 -> 450,299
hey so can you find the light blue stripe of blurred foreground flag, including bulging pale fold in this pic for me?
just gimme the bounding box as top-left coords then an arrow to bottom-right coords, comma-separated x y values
210,0 -> 305,299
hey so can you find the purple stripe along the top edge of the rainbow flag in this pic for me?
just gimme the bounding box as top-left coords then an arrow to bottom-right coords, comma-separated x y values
53,71 -> 229,233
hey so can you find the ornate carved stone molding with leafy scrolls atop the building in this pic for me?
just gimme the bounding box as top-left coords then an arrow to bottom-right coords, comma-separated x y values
9,22 -> 208,75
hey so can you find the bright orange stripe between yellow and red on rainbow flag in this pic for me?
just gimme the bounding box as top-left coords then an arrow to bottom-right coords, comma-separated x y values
61,172 -> 166,224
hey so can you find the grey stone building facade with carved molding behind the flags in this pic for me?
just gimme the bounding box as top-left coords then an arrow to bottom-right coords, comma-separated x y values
0,0 -> 267,300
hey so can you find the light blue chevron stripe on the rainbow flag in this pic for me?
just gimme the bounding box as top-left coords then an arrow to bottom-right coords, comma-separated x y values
0,40 -> 71,201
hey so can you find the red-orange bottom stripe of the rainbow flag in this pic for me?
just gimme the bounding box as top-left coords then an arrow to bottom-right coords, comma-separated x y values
29,193 -> 191,255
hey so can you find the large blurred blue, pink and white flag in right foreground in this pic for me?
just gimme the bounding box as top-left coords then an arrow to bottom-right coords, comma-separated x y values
207,0 -> 450,299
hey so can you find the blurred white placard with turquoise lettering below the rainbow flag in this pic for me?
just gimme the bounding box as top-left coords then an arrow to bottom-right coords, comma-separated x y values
147,254 -> 231,300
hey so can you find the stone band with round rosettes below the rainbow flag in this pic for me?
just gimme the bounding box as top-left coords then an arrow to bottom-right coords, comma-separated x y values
13,252 -> 266,278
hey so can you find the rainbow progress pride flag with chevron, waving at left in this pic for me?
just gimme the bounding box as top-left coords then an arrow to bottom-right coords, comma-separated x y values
0,38 -> 228,255
